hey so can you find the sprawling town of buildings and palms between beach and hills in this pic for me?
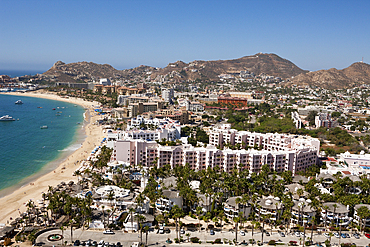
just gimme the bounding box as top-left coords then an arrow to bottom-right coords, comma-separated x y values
0,59 -> 370,247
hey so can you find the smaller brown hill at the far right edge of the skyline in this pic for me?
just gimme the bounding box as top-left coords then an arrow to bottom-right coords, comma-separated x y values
286,62 -> 370,89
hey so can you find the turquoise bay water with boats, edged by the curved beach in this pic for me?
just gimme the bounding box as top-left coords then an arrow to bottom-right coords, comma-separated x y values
0,94 -> 85,197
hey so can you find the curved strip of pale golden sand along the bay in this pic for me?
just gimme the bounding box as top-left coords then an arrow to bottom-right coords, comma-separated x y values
0,91 -> 105,224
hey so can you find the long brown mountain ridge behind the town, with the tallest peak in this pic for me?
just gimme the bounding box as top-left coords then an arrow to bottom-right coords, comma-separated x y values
44,53 -> 308,82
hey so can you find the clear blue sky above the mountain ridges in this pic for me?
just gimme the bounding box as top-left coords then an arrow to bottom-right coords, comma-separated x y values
0,0 -> 370,70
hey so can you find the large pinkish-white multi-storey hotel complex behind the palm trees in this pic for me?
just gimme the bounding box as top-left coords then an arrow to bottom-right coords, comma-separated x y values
108,120 -> 320,174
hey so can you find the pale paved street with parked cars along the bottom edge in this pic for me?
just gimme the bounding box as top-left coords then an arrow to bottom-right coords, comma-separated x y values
37,229 -> 370,247
